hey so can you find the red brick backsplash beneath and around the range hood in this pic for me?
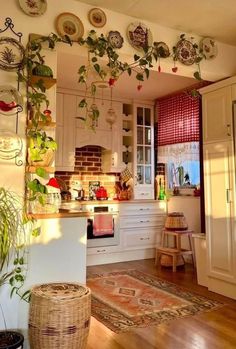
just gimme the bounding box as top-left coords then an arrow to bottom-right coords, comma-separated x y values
55,146 -> 120,198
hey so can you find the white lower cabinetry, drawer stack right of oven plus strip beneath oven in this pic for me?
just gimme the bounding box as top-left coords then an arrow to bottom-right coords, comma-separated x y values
87,200 -> 166,265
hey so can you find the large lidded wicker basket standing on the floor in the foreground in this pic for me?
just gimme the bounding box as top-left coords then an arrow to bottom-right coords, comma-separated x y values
29,283 -> 91,349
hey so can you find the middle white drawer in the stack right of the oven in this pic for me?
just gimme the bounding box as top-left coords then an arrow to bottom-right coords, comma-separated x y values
120,215 -> 165,228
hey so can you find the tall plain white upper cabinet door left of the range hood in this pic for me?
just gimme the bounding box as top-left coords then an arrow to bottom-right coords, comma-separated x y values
55,92 -> 76,171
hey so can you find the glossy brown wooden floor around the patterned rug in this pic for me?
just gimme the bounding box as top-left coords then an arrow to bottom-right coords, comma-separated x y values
87,259 -> 236,349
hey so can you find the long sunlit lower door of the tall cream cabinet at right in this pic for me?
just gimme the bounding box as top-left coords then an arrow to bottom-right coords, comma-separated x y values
204,142 -> 236,282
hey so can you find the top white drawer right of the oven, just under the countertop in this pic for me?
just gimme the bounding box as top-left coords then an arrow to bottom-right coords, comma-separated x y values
119,201 -> 166,216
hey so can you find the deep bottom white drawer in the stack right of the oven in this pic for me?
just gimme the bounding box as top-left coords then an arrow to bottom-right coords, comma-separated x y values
123,228 -> 161,249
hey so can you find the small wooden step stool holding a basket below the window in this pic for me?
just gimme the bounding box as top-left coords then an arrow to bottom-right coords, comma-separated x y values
155,229 -> 195,272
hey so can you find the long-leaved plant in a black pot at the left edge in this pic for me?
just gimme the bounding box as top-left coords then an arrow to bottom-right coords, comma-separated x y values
0,187 -> 38,349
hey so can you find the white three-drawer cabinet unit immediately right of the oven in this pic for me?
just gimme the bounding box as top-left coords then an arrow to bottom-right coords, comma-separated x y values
120,201 -> 166,251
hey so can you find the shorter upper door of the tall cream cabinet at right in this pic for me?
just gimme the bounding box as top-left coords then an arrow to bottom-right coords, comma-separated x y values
202,86 -> 233,143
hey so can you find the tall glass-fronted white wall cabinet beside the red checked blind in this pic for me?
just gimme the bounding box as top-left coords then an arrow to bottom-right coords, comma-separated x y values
133,104 -> 154,199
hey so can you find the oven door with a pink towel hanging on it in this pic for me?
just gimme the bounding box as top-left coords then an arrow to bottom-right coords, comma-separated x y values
87,213 -> 119,247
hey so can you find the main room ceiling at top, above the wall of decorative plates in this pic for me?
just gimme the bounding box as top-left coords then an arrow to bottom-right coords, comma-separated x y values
79,0 -> 236,46
